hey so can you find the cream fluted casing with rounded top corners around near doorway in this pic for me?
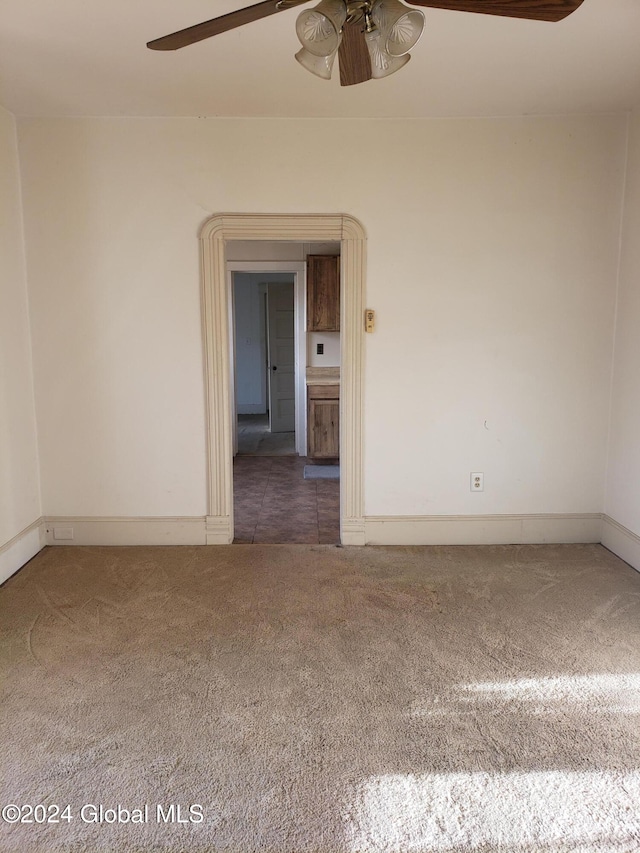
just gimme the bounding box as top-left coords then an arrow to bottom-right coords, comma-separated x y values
200,213 -> 366,545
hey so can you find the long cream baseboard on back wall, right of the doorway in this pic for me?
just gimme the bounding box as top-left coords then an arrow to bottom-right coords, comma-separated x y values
365,513 -> 602,545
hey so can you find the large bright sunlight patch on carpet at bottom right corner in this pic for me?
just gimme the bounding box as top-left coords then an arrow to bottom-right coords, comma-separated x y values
344,771 -> 640,853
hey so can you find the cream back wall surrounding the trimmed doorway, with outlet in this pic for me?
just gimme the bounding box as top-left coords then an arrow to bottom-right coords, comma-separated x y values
20,116 -> 626,516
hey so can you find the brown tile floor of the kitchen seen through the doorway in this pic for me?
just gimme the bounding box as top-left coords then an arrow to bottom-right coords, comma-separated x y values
233,455 -> 340,545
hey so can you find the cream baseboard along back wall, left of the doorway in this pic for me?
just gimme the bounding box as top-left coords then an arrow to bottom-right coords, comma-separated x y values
44,516 -> 206,545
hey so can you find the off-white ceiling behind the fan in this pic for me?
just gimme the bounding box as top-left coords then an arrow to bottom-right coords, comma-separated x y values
0,0 -> 640,118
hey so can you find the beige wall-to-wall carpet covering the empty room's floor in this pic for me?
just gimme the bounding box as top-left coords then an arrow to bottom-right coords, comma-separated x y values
0,545 -> 640,853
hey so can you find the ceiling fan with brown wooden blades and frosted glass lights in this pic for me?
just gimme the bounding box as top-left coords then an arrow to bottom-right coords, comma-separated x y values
147,0 -> 583,86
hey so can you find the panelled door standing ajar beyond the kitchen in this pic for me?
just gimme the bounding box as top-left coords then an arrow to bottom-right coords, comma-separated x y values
267,282 -> 296,432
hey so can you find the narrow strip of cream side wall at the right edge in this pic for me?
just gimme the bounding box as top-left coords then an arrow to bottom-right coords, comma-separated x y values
605,112 -> 640,540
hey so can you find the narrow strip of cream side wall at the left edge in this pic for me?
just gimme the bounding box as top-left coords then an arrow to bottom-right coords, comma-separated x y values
0,107 -> 41,560
